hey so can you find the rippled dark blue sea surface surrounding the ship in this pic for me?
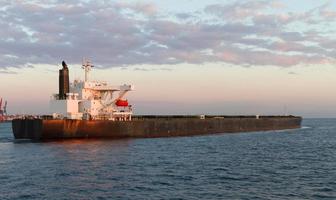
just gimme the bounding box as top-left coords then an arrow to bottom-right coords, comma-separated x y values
0,119 -> 336,200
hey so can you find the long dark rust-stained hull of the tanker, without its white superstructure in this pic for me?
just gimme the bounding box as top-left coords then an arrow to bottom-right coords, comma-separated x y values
12,116 -> 302,140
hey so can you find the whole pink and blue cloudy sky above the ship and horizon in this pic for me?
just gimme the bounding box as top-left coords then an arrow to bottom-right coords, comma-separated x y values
0,0 -> 336,117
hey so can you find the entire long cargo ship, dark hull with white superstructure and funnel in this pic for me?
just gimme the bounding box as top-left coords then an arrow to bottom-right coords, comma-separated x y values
12,60 -> 302,140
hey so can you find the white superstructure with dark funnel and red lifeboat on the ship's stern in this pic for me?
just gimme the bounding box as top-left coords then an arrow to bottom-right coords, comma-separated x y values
50,60 -> 134,121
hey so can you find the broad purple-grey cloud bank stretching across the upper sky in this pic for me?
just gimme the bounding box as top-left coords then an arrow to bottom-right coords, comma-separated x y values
0,0 -> 336,70
